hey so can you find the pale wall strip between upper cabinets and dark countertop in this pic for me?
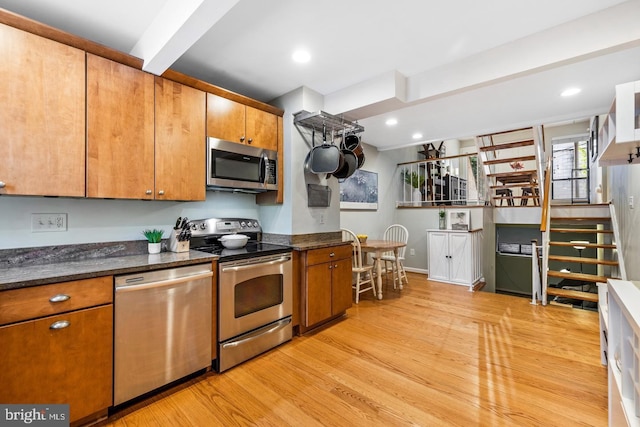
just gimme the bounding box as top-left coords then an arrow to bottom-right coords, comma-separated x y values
0,191 -> 258,249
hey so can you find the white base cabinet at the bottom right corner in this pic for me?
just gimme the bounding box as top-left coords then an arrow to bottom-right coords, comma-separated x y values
607,279 -> 640,427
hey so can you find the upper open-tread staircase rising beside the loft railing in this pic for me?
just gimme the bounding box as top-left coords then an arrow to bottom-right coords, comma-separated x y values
476,128 -> 541,207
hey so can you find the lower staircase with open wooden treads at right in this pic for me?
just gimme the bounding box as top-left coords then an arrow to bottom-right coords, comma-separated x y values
547,205 -> 619,309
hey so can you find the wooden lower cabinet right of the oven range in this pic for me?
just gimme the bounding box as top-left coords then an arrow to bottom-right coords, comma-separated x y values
300,244 -> 352,332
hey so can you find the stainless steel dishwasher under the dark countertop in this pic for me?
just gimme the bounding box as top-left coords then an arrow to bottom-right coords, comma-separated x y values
113,264 -> 213,405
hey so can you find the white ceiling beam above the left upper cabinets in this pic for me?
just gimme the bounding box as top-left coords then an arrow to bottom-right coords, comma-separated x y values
131,0 -> 239,76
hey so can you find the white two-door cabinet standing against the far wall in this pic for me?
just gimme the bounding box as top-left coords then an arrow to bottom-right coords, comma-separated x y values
427,230 -> 482,290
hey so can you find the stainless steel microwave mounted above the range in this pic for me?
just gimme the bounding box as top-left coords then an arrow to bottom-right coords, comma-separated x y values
207,138 -> 278,193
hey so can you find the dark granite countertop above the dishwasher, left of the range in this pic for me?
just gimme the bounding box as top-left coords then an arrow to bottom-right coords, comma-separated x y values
0,250 -> 218,291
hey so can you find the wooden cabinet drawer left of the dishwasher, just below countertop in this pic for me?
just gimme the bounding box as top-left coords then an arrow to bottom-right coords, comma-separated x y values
0,276 -> 113,325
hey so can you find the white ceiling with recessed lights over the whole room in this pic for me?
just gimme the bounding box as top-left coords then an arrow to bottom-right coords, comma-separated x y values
0,0 -> 640,150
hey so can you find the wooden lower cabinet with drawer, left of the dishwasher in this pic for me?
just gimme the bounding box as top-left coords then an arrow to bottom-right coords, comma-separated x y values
0,276 -> 113,424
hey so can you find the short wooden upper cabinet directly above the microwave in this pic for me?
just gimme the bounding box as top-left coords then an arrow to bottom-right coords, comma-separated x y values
207,93 -> 278,151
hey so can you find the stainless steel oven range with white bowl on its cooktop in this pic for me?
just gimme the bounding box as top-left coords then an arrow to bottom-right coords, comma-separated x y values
191,218 -> 293,372
